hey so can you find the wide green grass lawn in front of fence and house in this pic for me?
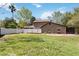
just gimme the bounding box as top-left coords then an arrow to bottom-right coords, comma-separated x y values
0,34 -> 79,56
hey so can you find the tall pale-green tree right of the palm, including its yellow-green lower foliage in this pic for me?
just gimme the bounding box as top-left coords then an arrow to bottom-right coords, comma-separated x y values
16,7 -> 32,28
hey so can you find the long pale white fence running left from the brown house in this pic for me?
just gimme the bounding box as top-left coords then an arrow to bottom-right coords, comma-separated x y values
0,28 -> 41,35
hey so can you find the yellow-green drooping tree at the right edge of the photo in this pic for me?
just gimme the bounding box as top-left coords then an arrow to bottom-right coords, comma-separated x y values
68,8 -> 79,27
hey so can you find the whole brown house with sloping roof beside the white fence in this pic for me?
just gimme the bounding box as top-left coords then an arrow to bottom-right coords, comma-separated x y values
33,21 -> 66,34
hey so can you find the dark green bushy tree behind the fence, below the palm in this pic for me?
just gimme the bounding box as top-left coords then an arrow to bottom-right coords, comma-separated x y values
3,17 -> 17,28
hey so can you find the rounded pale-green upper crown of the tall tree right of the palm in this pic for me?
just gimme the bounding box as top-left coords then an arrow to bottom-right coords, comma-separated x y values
16,7 -> 32,21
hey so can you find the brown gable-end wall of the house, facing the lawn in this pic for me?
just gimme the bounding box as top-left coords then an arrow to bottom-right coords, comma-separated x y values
41,24 -> 66,34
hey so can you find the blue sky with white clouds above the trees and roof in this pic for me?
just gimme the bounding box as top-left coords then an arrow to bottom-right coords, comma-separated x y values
0,3 -> 79,19
